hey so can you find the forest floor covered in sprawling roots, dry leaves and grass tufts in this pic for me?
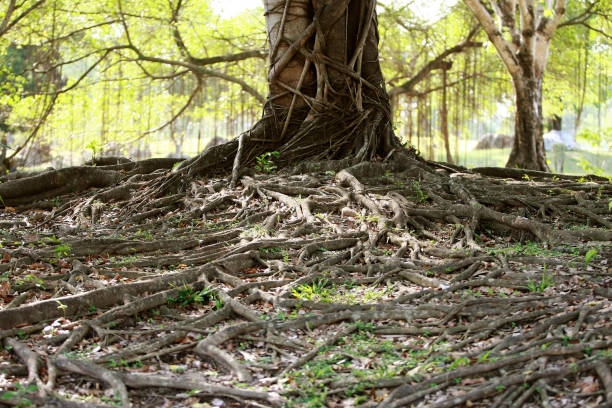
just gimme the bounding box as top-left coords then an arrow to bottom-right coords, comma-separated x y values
0,158 -> 612,408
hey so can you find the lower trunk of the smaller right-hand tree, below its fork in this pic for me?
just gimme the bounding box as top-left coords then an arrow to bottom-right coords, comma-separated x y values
506,78 -> 550,171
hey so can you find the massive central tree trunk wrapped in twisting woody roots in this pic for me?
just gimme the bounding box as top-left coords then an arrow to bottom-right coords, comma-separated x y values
258,0 -> 399,161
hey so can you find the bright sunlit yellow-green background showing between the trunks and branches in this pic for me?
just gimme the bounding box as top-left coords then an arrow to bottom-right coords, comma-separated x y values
0,0 -> 612,175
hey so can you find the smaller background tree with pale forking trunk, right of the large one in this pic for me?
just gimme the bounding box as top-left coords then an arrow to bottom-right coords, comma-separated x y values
464,0 -> 565,171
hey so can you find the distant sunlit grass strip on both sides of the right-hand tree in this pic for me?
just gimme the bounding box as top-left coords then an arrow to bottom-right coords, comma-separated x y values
436,148 -> 612,177
